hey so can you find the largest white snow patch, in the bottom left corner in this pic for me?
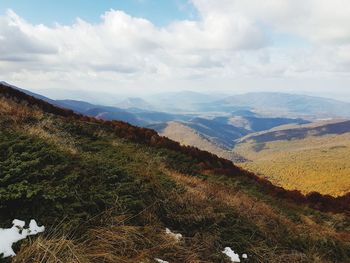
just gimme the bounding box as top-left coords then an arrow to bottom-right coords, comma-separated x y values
0,219 -> 45,258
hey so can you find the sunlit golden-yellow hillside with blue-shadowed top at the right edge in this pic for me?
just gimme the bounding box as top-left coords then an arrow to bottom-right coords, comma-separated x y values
234,121 -> 350,196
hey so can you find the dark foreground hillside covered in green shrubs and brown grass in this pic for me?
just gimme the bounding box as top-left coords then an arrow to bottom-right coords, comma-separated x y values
0,85 -> 350,263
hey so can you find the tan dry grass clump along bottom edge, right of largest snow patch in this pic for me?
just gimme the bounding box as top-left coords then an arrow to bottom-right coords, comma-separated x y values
13,216 -> 208,263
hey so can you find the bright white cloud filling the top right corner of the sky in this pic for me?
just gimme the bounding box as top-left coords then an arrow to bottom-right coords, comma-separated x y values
192,0 -> 350,42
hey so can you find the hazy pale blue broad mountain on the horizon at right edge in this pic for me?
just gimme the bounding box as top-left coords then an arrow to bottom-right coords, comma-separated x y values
201,92 -> 350,117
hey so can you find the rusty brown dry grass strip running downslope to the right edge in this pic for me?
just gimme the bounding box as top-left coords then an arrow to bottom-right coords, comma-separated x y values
164,171 -> 350,248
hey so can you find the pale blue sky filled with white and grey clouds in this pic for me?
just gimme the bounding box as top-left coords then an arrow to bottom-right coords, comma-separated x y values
0,0 -> 350,100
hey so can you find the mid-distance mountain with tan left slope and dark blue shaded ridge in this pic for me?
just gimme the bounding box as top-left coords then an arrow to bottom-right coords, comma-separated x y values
154,116 -> 309,162
